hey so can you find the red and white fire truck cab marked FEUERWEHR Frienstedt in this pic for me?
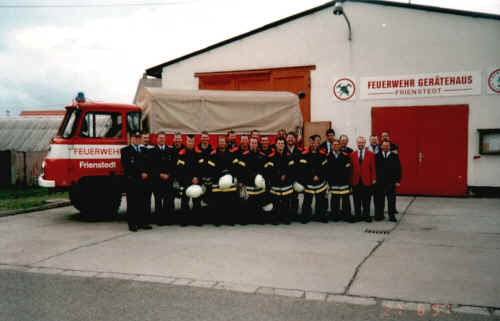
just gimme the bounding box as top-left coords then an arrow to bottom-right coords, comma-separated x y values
38,94 -> 141,216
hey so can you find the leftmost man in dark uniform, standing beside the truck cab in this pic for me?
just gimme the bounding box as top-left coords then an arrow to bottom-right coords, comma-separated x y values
121,132 -> 151,232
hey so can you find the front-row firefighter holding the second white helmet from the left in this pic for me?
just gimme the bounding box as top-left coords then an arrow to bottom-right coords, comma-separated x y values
207,136 -> 239,226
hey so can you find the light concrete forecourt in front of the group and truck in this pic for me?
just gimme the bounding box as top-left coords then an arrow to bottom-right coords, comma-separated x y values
0,197 -> 500,317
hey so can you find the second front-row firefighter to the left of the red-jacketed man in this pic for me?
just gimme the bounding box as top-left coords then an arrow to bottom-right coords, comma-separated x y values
298,135 -> 328,223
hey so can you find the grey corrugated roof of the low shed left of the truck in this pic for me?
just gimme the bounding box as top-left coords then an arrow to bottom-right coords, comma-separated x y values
0,116 -> 62,152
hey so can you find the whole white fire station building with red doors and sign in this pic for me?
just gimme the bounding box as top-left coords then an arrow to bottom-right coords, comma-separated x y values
146,0 -> 500,195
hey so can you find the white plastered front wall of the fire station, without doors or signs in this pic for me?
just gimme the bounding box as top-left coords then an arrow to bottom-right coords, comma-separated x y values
163,2 -> 500,186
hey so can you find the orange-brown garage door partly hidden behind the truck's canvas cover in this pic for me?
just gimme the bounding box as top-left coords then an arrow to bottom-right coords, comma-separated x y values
195,66 -> 315,121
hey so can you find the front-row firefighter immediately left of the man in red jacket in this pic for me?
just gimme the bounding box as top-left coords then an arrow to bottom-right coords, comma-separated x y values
326,139 -> 352,222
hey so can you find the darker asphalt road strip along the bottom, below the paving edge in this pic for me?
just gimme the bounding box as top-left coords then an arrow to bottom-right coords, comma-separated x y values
0,271 -> 494,321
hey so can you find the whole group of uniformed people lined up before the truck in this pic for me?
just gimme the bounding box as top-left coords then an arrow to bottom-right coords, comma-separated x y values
121,129 -> 401,231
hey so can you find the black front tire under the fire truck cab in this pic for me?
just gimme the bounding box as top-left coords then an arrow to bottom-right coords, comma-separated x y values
69,178 -> 122,220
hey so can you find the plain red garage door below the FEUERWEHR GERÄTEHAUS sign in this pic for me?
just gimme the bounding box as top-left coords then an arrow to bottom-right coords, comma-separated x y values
372,105 -> 469,196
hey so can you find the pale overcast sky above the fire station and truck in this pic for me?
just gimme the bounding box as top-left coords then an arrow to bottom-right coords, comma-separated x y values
0,0 -> 500,116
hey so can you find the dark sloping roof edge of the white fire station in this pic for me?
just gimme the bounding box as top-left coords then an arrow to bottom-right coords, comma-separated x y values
146,0 -> 500,78
